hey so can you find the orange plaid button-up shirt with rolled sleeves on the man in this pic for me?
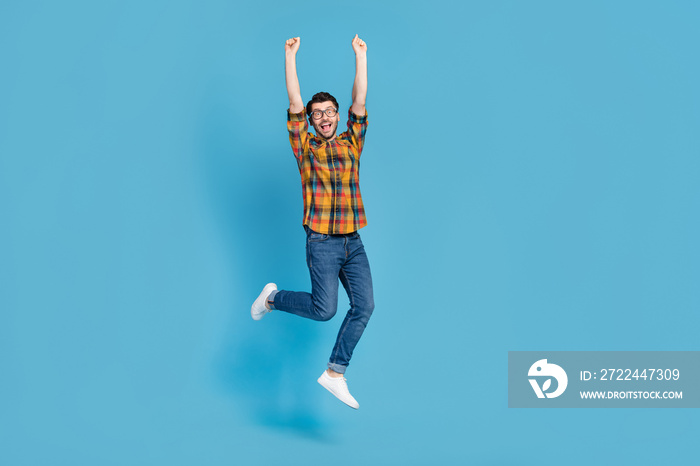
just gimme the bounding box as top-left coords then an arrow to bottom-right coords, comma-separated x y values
287,110 -> 367,235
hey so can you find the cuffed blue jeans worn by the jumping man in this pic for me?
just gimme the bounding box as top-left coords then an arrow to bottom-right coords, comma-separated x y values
272,226 -> 374,374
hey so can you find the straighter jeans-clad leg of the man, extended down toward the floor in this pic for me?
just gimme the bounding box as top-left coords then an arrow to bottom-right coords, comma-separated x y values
328,235 -> 374,374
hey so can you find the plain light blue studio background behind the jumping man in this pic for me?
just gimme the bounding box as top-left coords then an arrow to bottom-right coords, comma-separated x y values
0,0 -> 700,466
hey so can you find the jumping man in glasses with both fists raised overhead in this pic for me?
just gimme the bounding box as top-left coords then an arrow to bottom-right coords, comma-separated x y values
250,35 -> 374,409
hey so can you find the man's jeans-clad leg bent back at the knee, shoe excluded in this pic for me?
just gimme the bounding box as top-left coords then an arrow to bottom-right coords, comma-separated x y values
272,230 -> 345,321
